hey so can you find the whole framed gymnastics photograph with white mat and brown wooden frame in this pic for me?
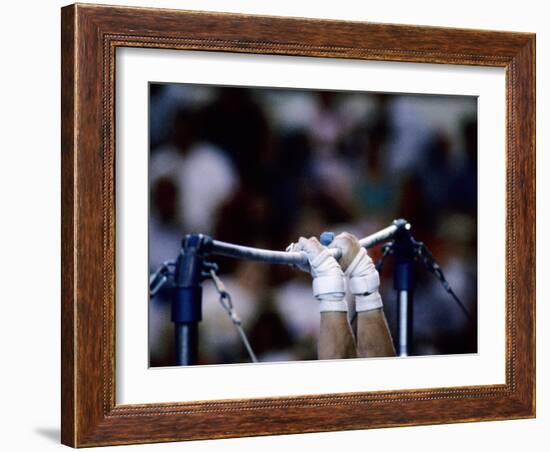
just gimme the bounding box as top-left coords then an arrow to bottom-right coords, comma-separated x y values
61,4 -> 535,447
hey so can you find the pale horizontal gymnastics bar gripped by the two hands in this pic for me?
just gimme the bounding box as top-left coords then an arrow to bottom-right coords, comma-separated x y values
207,220 -> 408,267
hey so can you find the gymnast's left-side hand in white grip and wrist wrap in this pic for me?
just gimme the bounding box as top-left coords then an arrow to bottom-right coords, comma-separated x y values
287,237 -> 347,312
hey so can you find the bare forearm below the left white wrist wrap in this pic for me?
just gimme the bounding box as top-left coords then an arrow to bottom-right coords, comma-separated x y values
318,312 -> 357,359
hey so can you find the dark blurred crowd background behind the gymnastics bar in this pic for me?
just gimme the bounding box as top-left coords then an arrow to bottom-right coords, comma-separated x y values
149,84 -> 477,366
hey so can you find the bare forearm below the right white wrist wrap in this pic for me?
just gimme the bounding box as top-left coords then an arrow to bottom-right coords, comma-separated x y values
357,308 -> 395,358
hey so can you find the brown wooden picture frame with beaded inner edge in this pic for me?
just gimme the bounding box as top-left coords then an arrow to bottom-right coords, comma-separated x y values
61,4 -> 535,447
